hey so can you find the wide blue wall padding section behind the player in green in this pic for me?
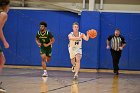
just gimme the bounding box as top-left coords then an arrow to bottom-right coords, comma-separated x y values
4,9 -> 79,67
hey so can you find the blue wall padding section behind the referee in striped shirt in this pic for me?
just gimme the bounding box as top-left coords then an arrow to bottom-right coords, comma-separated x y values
99,12 -> 140,70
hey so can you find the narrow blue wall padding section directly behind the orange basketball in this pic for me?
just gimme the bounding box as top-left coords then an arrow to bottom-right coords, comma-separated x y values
80,11 -> 100,68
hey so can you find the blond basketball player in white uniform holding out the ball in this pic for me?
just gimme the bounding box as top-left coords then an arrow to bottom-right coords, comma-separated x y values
68,22 -> 89,79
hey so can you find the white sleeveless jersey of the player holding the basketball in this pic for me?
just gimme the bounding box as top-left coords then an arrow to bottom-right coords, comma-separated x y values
69,32 -> 82,48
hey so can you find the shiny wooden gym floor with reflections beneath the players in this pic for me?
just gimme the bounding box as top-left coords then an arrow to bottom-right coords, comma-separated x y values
0,68 -> 140,93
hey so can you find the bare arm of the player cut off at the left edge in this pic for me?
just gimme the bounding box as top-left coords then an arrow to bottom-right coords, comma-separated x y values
0,13 -> 9,48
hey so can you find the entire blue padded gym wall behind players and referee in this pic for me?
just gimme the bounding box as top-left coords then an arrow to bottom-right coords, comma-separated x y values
3,9 -> 140,70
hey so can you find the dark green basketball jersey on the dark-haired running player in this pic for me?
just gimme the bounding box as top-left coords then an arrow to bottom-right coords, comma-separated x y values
36,30 -> 53,47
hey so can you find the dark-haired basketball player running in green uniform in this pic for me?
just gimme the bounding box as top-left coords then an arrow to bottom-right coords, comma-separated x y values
36,22 -> 55,77
